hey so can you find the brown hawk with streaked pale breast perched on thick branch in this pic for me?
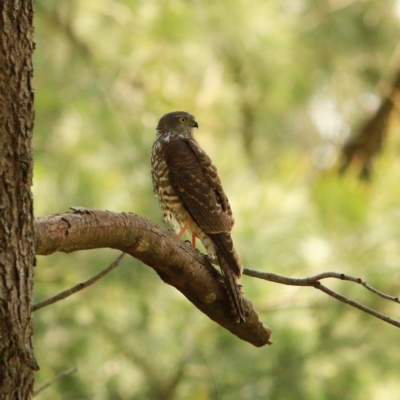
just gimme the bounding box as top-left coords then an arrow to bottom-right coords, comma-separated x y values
151,111 -> 245,322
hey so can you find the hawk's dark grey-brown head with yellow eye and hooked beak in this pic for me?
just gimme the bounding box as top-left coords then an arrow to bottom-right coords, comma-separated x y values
157,111 -> 199,137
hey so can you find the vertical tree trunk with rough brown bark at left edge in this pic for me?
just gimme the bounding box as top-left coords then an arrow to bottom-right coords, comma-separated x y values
0,0 -> 38,399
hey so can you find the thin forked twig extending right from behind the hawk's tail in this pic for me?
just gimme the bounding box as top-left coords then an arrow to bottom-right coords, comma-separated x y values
243,268 -> 400,328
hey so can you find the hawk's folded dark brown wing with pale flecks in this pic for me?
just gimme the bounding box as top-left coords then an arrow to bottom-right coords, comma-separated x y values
165,139 -> 234,233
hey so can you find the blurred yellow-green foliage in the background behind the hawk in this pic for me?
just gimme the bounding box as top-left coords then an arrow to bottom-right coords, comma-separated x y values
33,0 -> 400,400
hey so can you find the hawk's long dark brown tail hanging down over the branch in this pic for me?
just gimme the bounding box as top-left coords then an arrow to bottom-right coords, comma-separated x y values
208,233 -> 246,322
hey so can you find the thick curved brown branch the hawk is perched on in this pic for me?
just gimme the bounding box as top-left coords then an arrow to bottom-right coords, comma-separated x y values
35,208 -> 271,347
